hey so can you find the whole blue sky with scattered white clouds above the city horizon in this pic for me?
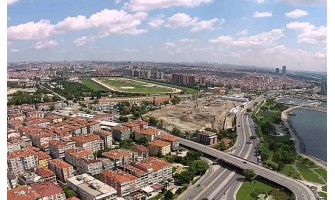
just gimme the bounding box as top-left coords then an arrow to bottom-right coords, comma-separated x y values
7,0 -> 327,71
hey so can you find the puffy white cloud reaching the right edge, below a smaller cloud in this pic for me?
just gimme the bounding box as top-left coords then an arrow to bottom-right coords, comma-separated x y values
286,22 -> 327,44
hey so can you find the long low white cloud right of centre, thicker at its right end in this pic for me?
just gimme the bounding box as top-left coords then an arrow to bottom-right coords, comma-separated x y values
209,29 -> 284,47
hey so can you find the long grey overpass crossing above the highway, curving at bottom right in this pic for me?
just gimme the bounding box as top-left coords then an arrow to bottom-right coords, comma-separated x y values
177,137 -> 316,200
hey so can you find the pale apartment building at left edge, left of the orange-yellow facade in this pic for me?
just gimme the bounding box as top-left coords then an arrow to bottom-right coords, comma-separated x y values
7,148 -> 38,175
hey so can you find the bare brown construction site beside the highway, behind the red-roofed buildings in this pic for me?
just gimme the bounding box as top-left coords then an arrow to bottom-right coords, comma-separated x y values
144,96 -> 241,132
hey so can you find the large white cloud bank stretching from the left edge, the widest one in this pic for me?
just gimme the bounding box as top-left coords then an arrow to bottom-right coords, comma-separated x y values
7,9 -> 147,40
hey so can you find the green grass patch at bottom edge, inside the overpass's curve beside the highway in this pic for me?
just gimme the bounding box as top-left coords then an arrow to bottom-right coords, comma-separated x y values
236,180 -> 272,200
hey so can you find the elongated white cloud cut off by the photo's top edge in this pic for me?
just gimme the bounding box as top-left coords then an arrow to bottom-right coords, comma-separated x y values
126,0 -> 212,11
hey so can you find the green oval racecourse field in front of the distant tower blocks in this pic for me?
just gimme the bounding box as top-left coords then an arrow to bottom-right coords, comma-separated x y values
92,78 -> 181,94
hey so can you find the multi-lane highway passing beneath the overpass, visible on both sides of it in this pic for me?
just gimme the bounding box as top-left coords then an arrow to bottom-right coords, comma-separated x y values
181,97 -> 262,200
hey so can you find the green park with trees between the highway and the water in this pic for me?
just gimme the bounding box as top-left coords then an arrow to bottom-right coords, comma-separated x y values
253,99 -> 327,196
